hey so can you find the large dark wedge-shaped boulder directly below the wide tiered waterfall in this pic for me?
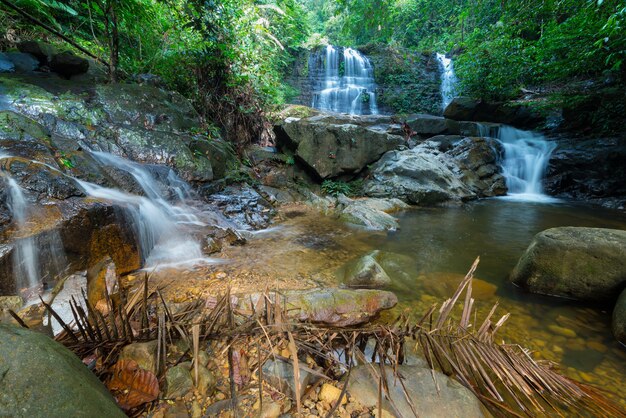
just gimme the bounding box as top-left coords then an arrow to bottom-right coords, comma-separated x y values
275,114 -> 404,179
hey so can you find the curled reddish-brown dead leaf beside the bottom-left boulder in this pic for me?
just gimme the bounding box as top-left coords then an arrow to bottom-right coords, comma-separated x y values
107,360 -> 159,410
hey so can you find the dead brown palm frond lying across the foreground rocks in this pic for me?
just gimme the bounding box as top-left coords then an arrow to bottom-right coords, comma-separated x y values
11,259 -> 626,417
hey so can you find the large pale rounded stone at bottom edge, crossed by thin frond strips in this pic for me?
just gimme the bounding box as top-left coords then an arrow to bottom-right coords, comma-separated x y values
348,365 -> 486,418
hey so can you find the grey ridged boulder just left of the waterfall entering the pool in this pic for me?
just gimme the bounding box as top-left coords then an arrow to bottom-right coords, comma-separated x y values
364,136 -> 506,205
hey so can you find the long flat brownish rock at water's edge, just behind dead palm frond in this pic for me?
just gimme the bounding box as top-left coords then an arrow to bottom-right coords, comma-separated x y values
237,288 -> 398,327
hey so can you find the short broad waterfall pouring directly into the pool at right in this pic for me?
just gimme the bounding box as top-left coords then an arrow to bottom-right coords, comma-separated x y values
481,125 -> 556,201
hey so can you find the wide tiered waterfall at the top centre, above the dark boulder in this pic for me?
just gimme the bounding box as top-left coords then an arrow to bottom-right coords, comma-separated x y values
310,45 -> 378,115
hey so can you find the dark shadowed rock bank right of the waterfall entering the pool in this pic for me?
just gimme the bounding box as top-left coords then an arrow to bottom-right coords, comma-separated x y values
544,135 -> 626,209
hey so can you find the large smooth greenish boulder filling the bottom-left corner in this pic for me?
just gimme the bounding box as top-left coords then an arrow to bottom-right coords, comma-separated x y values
0,324 -> 126,417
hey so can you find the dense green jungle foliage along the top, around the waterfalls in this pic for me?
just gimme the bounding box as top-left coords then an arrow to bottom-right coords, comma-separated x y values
0,0 -> 626,140
